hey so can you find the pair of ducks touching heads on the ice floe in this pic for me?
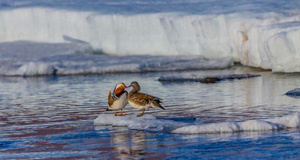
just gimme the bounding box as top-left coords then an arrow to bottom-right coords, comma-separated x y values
106,81 -> 165,117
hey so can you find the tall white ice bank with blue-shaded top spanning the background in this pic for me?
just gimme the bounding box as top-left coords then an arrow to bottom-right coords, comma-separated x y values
0,0 -> 300,72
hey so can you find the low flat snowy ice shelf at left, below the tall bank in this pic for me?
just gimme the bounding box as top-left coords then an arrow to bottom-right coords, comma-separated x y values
0,41 -> 233,76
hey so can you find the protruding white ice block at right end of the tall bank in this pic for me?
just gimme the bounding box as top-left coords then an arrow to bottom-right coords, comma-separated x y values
246,21 -> 300,72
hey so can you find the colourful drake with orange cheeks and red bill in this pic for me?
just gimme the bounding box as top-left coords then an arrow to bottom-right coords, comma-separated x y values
106,83 -> 128,116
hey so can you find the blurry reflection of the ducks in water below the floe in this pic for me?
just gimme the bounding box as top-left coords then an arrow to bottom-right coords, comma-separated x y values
111,131 -> 149,159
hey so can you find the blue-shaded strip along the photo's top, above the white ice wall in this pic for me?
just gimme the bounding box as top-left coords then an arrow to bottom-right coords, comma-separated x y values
0,0 -> 299,15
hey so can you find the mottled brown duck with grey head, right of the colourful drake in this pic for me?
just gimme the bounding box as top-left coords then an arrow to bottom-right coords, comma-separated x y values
128,81 -> 165,117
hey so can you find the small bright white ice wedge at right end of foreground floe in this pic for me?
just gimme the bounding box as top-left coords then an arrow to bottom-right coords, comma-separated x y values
265,113 -> 300,128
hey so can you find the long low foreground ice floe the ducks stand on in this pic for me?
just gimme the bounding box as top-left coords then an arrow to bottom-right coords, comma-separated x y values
94,113 -> 300,134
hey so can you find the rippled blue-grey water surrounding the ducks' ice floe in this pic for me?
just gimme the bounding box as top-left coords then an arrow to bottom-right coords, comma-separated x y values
0,65 -> 300,159
